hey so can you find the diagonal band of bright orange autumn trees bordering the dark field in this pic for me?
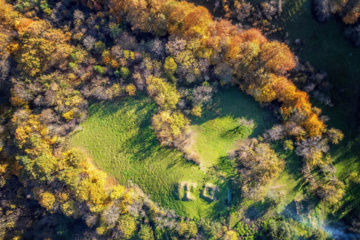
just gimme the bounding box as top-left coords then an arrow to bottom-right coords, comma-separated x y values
111,0 -> 325,137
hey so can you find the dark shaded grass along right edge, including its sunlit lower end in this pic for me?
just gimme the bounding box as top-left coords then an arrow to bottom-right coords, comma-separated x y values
278,0 -> 360,224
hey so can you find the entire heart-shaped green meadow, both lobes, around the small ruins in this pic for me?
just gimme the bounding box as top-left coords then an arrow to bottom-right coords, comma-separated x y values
67,89 -> 272,218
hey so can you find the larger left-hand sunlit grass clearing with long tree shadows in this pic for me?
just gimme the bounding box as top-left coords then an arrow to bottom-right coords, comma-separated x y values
68,96 -> 209,217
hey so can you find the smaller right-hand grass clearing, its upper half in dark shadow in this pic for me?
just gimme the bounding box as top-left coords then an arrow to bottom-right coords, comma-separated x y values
192,89 -> 275,167
